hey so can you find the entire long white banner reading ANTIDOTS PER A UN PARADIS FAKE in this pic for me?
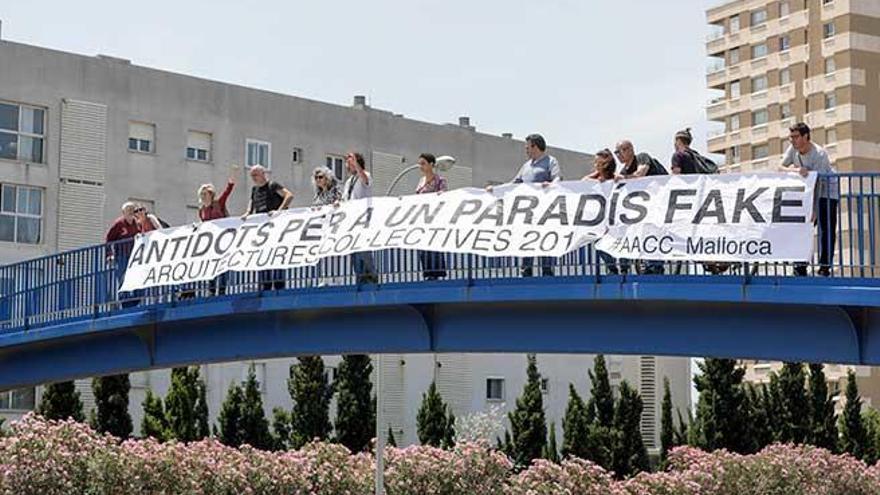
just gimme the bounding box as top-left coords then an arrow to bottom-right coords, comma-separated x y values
120,174 -> 816,291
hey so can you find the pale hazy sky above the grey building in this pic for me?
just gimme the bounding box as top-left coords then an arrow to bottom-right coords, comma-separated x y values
0,0 -> 717,161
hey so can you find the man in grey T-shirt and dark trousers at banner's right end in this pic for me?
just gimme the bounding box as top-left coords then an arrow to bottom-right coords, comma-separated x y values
779,122 -> 840,277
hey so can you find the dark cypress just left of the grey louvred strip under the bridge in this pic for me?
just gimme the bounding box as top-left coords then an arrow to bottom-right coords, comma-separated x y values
613,380 -> 648,478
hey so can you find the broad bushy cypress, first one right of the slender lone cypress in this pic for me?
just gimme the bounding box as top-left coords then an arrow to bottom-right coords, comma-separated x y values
689,358 -> 751,453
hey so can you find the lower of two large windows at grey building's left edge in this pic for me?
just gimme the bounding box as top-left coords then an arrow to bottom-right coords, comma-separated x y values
0,184 -> 43,244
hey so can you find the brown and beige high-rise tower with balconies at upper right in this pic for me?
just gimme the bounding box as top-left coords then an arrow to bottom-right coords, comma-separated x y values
706,0 -> 880,172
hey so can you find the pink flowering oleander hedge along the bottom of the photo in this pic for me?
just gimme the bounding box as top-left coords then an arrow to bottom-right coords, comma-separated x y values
0,415 -> 880,495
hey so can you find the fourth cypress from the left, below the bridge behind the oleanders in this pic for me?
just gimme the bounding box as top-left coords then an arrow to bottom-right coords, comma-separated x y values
165,366 -> 208,442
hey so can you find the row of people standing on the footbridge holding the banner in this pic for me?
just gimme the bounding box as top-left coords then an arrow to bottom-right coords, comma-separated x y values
105,123 -> 839,304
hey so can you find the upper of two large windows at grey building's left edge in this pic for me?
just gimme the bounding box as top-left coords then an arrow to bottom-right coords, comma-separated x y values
0,102 -> 46,163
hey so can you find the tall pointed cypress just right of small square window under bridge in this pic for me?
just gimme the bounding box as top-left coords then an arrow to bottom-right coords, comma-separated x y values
507,354 -> 547,469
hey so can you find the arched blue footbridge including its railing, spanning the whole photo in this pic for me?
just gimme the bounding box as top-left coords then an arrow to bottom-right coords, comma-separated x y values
0,176 -> 880,389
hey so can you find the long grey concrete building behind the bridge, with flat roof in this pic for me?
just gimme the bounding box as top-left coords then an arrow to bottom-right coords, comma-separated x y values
0,36 -> 690,447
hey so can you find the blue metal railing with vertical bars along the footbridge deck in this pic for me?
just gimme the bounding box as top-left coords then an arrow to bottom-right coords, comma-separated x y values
0,173 -> 880,332
